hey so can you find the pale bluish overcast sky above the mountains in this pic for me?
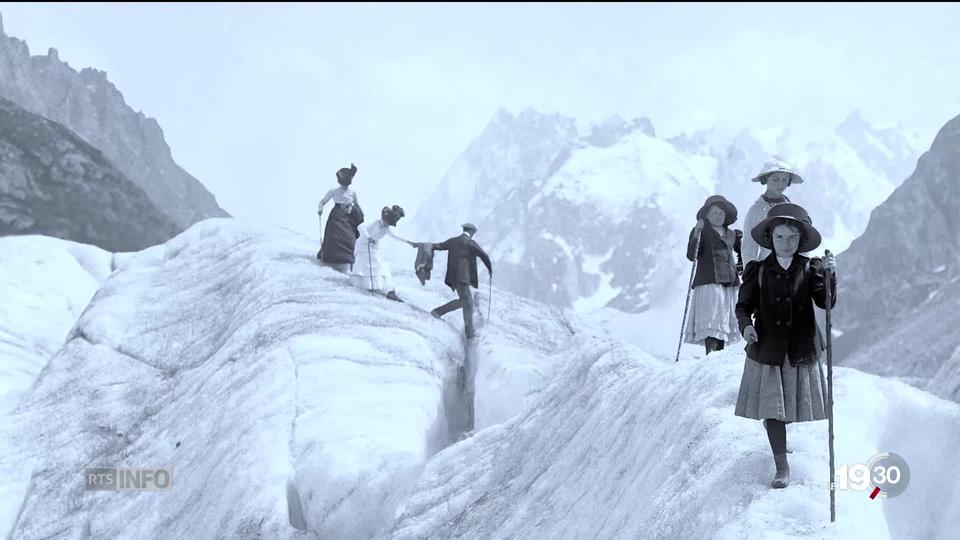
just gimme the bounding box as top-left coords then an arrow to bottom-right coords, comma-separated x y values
0,3 -> 960,235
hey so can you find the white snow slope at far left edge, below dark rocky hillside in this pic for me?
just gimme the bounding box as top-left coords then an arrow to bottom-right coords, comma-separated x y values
0,235 -> 113,416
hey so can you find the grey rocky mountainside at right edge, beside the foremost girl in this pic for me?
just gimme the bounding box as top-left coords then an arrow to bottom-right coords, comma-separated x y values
834,112 -> 960,399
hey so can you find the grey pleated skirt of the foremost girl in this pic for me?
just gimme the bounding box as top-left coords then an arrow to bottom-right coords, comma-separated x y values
734,357 -> 827,422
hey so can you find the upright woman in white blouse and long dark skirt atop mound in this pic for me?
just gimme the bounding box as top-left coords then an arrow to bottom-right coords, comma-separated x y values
317,163 -> 363,273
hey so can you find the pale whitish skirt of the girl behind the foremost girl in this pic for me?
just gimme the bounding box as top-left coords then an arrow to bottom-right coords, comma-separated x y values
683,283 -> 740,345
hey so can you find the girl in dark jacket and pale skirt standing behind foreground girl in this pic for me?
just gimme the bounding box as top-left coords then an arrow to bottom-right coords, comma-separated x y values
684,195 -> 740,354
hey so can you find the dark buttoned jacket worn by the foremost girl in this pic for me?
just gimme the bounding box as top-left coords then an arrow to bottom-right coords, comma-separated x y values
736,253 -> 837,366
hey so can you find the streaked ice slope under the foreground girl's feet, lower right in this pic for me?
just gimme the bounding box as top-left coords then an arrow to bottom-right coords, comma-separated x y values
388,340 -> 960,539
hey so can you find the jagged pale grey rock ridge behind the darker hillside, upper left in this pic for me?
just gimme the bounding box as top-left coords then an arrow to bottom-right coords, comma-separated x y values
0,15 -> 228,230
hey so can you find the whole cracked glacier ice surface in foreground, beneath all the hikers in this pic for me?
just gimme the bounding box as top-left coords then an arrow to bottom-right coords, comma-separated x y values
0,219 -> 960,539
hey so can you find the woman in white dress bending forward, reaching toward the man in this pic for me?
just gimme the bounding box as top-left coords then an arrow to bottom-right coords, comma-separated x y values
350,205 -> 415,302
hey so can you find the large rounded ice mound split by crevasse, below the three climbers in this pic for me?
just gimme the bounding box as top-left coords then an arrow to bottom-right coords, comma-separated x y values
0,219 -> 573,538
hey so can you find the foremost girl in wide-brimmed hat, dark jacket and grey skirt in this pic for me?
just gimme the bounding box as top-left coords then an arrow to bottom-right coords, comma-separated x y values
734,203 -> 837,488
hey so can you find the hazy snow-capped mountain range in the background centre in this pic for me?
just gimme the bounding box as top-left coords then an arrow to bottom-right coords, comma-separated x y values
415,108 -> 918,312
